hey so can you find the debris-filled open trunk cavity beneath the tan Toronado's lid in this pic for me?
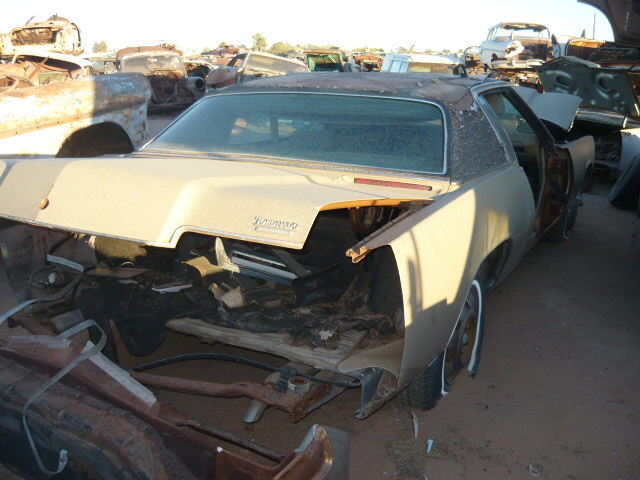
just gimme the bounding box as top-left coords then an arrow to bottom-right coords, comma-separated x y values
0,204 -> 416,370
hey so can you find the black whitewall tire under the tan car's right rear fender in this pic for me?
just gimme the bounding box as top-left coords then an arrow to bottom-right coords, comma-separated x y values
400,280 -> 484,410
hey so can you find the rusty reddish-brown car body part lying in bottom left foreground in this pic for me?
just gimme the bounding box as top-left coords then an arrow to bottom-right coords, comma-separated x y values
0,335 -> 348,480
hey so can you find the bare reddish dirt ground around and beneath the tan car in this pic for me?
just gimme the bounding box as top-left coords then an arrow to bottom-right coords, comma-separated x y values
0,184 -> 640,480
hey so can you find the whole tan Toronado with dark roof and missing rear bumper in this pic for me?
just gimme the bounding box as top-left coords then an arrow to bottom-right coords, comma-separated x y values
0,73 -> 594,478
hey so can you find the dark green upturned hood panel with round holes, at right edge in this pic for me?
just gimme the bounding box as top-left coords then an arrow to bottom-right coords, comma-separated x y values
537,57 -> 640,119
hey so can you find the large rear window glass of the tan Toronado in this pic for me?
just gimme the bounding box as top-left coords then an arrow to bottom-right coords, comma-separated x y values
145,93 -> 444,173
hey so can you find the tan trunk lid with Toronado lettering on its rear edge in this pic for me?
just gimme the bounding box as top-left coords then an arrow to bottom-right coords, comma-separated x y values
0,155 -> 449,248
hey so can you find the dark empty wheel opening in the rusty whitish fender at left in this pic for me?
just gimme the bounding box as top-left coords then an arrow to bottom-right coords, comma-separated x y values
56,122 -> 133,158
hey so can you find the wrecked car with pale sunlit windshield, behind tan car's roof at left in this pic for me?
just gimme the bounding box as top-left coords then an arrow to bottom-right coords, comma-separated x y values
207,52 -> 309,90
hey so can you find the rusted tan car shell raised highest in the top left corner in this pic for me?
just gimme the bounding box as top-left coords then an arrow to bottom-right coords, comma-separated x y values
0,15 -> 84,55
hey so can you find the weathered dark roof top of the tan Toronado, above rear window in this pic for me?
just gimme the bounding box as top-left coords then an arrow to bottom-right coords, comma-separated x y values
223,72 -> 480,109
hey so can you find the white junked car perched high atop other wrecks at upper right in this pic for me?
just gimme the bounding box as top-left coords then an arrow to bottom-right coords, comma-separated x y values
480,22 -> 553,69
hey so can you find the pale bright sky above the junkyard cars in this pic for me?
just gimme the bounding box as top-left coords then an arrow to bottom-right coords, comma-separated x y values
0,0 -> 613,51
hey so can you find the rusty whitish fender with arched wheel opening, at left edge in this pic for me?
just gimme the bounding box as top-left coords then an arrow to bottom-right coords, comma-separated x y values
0,73 -> 151,156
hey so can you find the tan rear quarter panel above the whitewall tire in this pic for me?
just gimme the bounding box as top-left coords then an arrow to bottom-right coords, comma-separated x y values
344,167 -> 535,386
